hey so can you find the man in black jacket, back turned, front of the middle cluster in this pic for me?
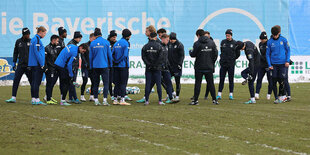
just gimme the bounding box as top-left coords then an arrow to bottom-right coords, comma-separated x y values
141,32 -> 165,105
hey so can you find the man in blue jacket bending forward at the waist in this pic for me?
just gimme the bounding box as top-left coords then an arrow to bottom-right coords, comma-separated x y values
55,44 -> 88,106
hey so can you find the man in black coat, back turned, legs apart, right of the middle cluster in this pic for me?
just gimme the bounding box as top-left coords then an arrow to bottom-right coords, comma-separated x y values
189,29 -> 219,105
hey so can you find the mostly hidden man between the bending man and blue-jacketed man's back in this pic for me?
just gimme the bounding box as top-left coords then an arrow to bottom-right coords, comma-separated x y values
81,33 -> 96,102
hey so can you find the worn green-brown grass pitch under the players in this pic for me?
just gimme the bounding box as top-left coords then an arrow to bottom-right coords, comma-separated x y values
0,83 -> 310,154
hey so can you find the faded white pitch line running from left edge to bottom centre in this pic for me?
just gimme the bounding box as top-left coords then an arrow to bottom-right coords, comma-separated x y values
8,110 -> 197,155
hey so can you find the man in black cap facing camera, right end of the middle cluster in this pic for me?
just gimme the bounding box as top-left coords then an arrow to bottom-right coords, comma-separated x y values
168,32 -> 184,102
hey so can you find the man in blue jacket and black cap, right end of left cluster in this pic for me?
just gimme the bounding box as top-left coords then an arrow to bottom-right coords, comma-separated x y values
112,29 -> 131,105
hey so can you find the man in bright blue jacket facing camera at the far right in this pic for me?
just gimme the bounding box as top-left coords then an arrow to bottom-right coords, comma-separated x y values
266,25 -> 291,104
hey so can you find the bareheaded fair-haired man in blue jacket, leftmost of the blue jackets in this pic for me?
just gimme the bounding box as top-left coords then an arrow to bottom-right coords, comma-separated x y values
28,26 -> 46,105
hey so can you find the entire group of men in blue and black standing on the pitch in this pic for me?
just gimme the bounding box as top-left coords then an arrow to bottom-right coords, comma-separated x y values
6,25 -> 291,105
